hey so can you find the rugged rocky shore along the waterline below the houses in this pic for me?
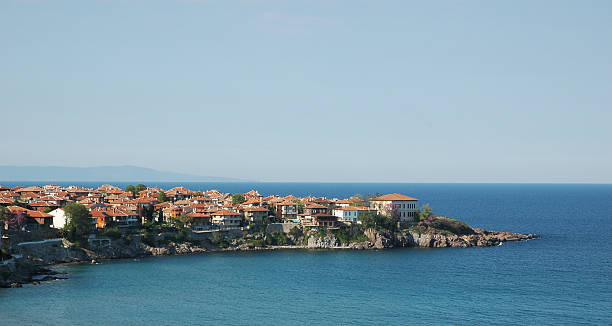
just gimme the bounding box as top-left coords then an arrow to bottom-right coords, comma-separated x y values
0,228 -> 538,287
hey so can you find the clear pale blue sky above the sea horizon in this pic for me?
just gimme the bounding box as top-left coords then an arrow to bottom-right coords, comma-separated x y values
0,0 -> 612,183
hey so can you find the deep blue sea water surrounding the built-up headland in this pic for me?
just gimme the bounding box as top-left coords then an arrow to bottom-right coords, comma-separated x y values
0,183 -> 612,325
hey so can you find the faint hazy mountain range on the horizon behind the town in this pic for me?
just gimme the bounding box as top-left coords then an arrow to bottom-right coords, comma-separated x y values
0,165 -> 246,182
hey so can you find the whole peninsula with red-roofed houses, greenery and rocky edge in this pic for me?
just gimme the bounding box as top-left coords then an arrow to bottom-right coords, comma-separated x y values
0,184 -> 538,287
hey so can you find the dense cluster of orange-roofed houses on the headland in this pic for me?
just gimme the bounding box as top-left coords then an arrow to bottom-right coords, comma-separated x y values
0,184 -> 418,231
